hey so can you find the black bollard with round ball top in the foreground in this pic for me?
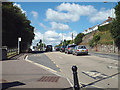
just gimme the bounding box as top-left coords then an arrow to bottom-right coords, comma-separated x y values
72,66 -> 80,90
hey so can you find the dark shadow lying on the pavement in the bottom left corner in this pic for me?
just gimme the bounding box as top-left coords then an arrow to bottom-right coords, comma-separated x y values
0,81 -> 25,90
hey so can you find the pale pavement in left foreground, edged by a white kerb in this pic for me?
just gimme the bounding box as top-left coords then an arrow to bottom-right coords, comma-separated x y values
0,54 -> 73,90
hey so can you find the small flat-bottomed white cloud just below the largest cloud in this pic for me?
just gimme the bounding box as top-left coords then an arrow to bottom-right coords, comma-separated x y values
50,22 -> 71,30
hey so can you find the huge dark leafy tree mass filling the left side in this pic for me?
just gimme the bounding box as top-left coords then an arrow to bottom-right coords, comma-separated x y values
2,2 -> 35,52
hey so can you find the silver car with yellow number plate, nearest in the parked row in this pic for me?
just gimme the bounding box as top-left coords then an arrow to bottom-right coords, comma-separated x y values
73,45 -> 88,56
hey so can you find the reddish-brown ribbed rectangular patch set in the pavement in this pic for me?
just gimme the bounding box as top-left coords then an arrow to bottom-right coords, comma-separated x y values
38,76 -> 60,82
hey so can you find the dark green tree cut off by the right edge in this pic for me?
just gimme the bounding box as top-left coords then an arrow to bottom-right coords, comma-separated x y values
110,2 -> 120,52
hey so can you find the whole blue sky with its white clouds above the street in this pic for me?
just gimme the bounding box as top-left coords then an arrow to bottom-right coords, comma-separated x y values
11,2 -> 117,46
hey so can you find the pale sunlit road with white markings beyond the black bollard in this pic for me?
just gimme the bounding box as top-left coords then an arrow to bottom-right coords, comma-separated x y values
28,52 -> 118,88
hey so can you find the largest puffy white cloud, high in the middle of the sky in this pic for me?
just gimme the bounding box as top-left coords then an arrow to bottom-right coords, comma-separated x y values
46,3 -> 96,22
